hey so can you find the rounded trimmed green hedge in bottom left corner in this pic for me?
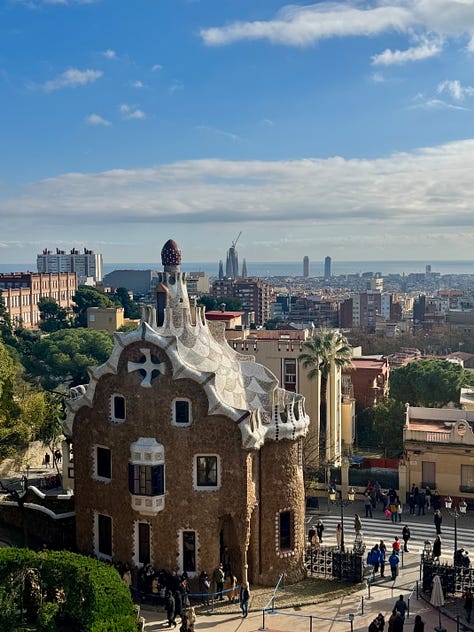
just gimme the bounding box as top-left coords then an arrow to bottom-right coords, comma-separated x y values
0,547 -> 137,632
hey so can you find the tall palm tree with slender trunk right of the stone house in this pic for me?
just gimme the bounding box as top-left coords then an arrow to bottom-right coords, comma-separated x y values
298,329 -> 352,465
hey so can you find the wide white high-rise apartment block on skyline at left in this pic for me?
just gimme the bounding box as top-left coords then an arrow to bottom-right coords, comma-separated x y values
36,248 -> 103,284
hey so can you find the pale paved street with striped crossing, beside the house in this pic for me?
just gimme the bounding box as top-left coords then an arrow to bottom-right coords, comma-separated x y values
142,501 -> 474,632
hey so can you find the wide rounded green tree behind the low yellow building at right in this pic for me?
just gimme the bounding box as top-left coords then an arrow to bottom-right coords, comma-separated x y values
390,360 -> 474,408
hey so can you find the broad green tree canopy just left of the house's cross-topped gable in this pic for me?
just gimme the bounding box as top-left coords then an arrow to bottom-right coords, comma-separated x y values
28,328 -> 113,390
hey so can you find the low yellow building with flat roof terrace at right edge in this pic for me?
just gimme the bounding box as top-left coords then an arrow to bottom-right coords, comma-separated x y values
400,406 -> 474,502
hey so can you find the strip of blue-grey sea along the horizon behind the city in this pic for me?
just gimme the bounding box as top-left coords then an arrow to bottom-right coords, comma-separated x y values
0,259 -> 474,277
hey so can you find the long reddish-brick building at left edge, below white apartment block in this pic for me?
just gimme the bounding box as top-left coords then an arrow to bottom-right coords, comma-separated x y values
0,272 -> 77,329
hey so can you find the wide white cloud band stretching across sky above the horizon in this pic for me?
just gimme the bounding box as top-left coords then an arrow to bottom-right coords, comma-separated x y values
0,139 -> 474,241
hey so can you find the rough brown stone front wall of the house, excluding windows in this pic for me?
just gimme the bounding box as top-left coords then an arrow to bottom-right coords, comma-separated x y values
73,342 -> 252,575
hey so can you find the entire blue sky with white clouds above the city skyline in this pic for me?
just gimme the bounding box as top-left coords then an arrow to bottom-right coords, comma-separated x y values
0,0 -> 474,263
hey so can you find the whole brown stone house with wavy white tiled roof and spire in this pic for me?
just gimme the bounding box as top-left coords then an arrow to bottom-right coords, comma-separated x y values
63,240 -> 309,585
